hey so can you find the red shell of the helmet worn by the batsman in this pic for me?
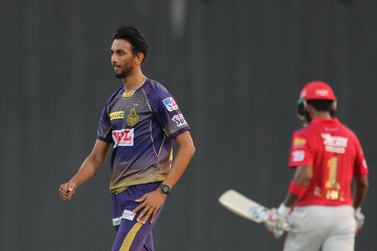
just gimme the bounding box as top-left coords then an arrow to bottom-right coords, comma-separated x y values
300,81 -> 336,101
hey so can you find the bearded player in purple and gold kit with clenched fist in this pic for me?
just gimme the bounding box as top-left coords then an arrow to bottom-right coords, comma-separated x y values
59,26 -> 195,251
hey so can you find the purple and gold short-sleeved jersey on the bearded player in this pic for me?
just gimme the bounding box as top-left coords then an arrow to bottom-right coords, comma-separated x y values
97,79 -> 189,193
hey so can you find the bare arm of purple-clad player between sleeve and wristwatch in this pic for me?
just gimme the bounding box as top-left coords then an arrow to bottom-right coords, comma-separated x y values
164,131 -> 196,188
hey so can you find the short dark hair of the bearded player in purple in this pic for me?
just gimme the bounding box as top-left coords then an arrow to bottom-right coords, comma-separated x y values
113,26 -> 149,59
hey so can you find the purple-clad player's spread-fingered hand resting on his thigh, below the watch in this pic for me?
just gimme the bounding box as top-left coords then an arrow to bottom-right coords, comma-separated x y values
133,188 -> 167,224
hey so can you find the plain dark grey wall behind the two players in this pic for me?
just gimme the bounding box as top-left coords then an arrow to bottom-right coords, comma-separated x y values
0,0 -> 377,251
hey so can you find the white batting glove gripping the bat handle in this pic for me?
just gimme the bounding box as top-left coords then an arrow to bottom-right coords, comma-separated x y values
265,203 -> 291,239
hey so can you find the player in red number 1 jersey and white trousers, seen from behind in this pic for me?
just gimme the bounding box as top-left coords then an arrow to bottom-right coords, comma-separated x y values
266,81 -> 368,251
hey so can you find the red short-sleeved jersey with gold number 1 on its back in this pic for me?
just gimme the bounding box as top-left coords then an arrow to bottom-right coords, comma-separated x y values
289,118 -> 368,206
